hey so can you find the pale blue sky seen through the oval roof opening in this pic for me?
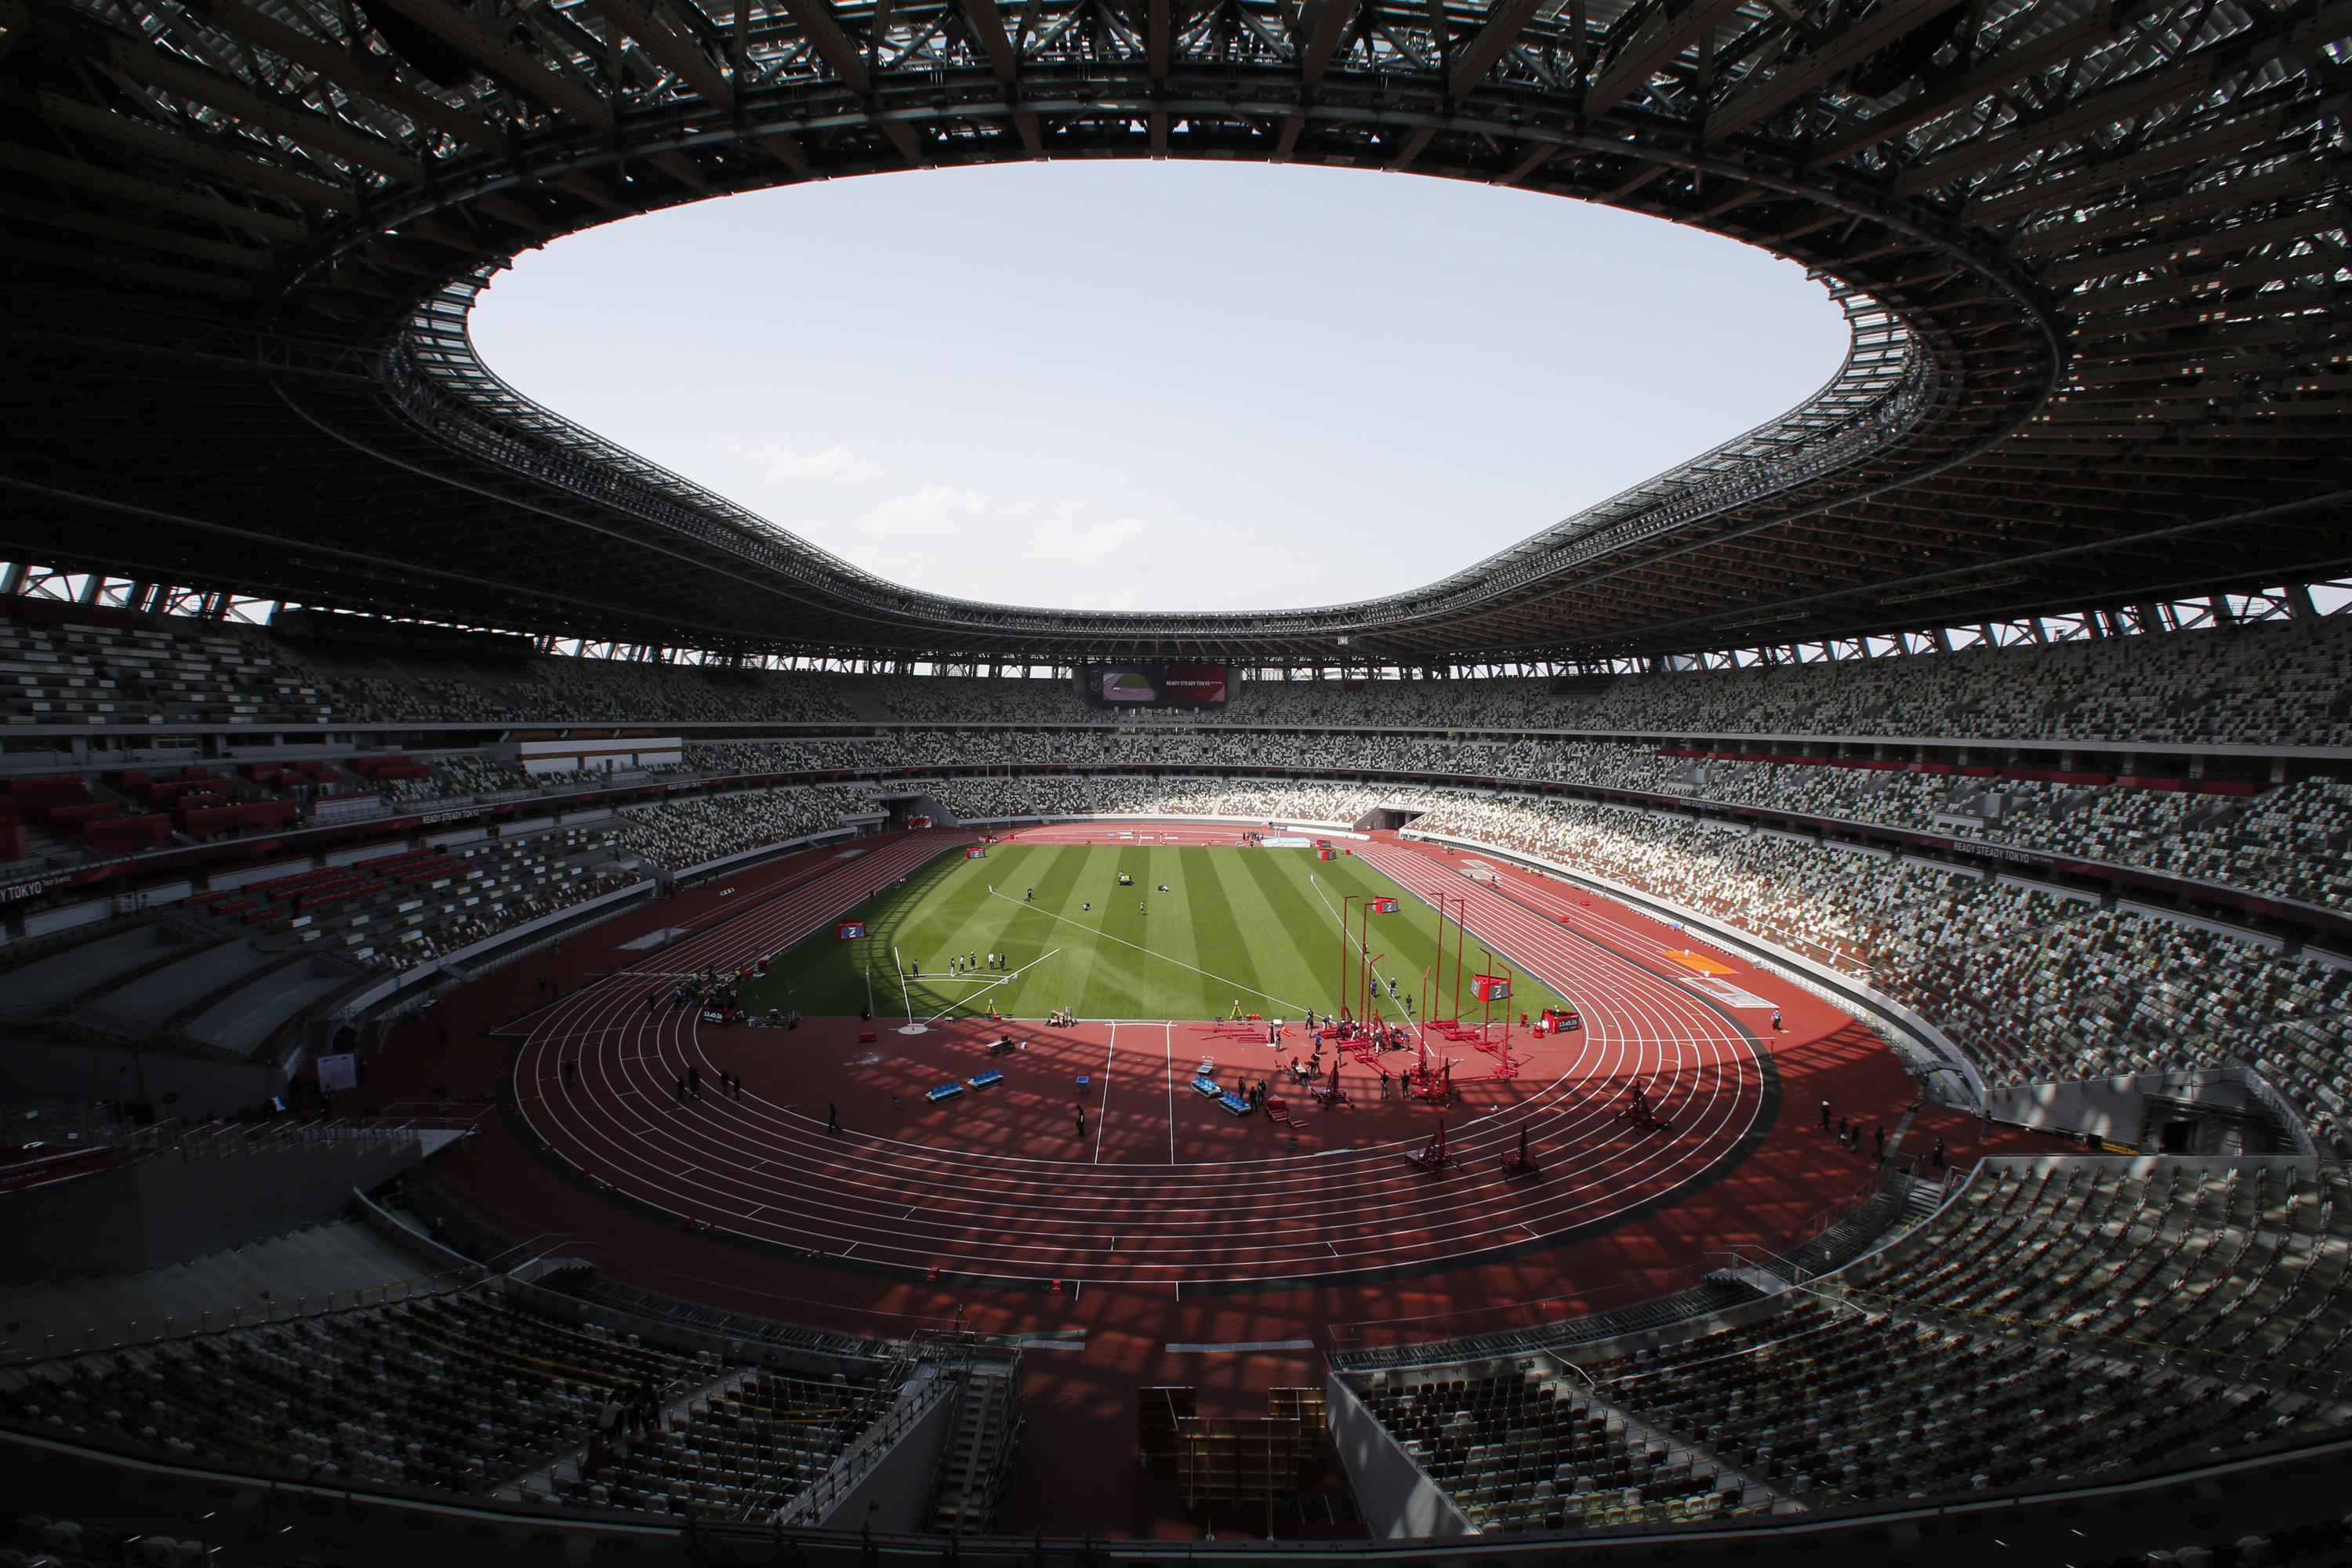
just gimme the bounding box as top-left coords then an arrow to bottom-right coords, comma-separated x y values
473,162 -> 1846,609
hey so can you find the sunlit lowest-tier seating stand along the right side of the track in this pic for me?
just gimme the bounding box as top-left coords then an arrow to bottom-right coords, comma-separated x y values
1414,794 -> 2352,1154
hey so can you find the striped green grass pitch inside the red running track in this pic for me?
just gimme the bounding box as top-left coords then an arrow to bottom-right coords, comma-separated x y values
746,844 -> 1559,1020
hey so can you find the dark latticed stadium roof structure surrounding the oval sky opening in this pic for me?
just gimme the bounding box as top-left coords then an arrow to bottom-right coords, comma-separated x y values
0,0 -> 2352,663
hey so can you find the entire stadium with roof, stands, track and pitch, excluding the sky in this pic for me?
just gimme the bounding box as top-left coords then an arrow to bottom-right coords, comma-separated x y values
0,0 -> 2352,1568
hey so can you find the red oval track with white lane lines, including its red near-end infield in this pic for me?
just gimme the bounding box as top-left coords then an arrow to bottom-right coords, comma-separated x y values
510,825 -> 1769,1293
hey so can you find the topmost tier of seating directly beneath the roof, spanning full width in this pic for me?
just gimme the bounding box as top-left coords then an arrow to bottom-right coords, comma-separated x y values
0,607 -> 2352,746
